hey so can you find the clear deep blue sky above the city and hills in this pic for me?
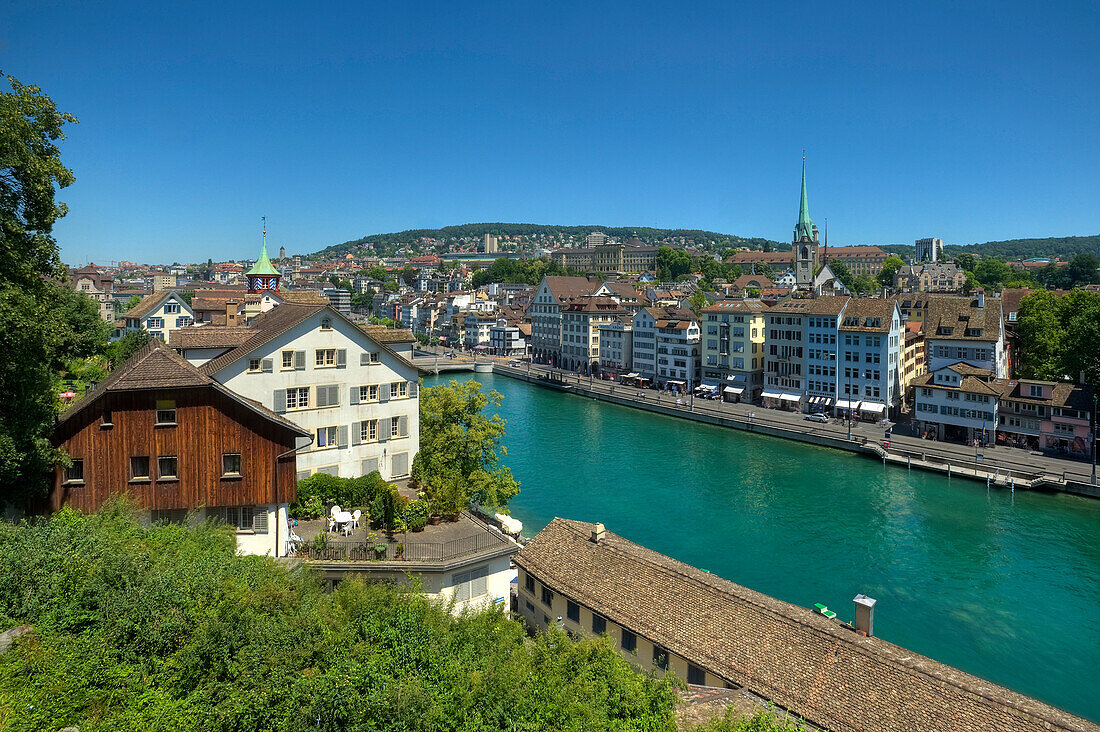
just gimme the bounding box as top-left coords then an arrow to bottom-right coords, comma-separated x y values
0,0 -> 1100,262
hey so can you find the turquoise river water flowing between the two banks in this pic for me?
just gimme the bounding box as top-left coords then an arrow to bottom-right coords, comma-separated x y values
426,374 -> 1100,721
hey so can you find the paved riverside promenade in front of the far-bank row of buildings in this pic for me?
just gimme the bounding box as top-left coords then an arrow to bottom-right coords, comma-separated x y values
493,360 -> 1100,498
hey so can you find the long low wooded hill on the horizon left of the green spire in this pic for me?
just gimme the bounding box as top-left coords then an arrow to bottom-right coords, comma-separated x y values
317,223 -> 790,256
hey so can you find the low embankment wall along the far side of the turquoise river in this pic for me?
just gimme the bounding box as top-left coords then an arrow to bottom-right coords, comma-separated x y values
493,363 -> 1100,499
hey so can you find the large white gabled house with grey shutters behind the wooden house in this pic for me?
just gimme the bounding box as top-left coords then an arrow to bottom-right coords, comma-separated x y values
169,303 -> 420,480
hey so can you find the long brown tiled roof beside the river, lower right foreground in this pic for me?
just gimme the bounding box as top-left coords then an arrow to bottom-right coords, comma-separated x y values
515,518 -> 1100,732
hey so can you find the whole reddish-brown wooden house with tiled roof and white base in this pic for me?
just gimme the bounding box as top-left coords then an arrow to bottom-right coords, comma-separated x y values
50,339 -> 309,556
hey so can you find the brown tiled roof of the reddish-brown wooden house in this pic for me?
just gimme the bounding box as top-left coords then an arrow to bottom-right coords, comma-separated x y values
57,338 -> 309,436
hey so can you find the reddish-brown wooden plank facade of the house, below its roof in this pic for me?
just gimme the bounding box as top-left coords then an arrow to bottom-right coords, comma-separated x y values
50,385 -> 296,512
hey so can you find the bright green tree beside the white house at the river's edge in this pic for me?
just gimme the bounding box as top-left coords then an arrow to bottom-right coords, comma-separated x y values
413,380 -> 519,513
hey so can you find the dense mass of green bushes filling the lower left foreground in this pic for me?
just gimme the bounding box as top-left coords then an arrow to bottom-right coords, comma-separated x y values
0,504 -> 674,732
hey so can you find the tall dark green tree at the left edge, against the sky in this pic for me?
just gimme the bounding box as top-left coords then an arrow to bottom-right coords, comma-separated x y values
0,76 -> 107,504
